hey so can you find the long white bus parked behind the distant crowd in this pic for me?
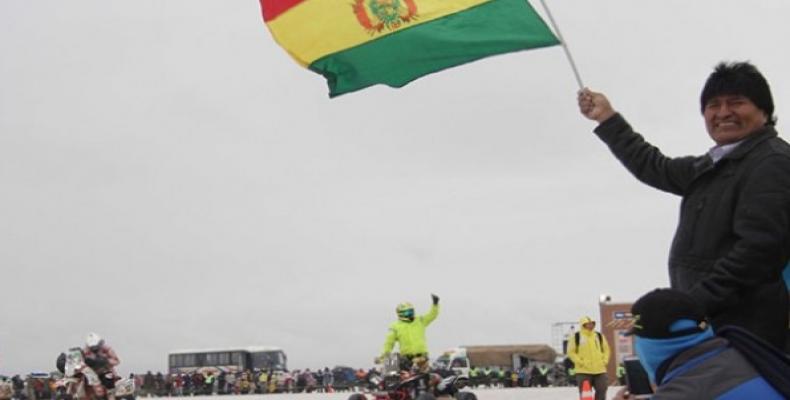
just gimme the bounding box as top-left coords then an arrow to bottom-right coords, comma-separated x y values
167,346 -> 288,374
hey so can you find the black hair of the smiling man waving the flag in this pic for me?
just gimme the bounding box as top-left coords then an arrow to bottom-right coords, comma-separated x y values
700,61 -> 776,125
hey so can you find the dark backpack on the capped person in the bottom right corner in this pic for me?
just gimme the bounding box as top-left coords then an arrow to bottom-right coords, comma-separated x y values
716,325 -> 790,398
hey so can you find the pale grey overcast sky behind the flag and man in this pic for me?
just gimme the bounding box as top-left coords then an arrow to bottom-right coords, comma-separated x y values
0,0 -> 790,374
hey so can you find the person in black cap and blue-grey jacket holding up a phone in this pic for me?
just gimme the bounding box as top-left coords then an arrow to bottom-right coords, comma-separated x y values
615,289 -> 784,400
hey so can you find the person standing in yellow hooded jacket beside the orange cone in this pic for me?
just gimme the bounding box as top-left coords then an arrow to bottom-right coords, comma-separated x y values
568,316 -> 610,400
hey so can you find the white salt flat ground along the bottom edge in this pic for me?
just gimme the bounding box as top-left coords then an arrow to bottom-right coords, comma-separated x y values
162,386 -> 620,400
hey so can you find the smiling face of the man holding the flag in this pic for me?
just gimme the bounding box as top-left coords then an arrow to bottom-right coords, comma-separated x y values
702,95 -> 768,145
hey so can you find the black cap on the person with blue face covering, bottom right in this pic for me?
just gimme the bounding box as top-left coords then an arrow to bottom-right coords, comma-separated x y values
628,289 -> 708,339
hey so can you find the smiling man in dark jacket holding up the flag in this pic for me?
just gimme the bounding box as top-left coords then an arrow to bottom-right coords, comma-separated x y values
578,62 -> 790,350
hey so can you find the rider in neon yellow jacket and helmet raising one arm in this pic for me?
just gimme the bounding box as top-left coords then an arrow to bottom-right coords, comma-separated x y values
379,294 -> 439,370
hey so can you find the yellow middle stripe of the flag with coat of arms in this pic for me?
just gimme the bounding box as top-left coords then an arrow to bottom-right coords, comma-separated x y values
267,0 -> 498,67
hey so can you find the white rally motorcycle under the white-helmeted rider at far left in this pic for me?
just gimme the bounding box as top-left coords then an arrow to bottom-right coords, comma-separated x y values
55,347 -> 135,400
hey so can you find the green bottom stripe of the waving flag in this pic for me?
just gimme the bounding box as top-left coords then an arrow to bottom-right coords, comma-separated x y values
310,0 -> 559,97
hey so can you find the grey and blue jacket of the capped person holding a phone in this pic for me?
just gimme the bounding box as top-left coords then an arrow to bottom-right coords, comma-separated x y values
652,338 -> 784,400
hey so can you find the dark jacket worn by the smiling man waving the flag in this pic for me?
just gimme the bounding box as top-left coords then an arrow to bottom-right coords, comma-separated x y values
595,114 -> 790,348
